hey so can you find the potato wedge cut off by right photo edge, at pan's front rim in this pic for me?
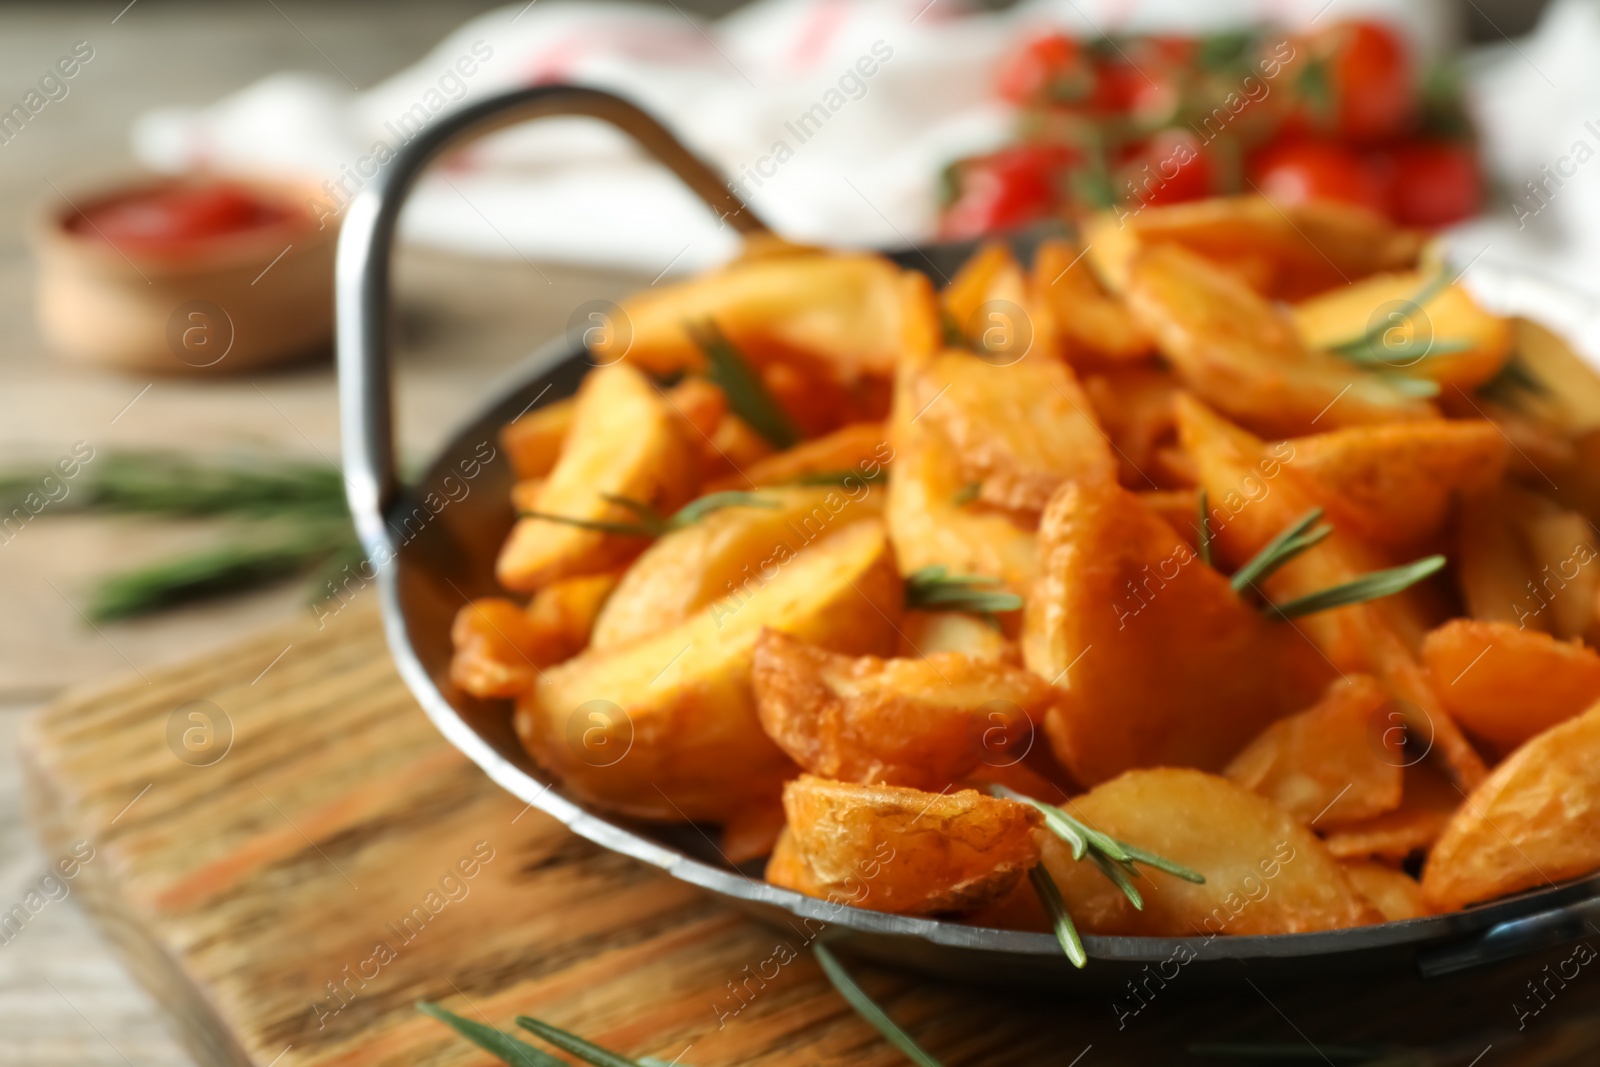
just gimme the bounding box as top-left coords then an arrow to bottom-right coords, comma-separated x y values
1422,705 -> 1600,912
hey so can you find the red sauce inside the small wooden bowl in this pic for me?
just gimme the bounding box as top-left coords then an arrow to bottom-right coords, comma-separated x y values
67,181 -> 302,256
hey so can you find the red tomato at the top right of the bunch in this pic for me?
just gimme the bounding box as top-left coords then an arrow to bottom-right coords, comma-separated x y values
1328,21 -> 1416,141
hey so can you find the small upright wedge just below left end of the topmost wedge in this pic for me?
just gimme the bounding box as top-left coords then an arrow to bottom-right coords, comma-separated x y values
1030,240 -> 1155,371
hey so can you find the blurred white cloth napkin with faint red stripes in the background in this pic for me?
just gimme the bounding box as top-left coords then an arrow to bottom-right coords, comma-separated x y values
133,0 -> 1472,275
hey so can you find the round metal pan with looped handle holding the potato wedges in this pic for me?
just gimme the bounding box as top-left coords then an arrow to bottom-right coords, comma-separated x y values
338,86 -> 1600,987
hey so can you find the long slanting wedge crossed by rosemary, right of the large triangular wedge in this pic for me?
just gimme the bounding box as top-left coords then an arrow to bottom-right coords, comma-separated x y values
1178,397 -> 1486,789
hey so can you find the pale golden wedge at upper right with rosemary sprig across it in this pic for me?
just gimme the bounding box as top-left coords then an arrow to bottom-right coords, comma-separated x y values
1293,270 -> 1512,390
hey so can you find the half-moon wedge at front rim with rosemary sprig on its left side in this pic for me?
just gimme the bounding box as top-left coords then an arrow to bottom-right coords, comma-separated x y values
1043,768 -> 1382,937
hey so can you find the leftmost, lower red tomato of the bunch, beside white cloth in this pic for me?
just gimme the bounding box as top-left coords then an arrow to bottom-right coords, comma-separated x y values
939,144 -> 1082,240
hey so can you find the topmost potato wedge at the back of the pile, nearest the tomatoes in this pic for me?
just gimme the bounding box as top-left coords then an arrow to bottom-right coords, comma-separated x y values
1083,197 -> 1426,301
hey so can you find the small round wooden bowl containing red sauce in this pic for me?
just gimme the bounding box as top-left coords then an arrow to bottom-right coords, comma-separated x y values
29,176 -> 338,374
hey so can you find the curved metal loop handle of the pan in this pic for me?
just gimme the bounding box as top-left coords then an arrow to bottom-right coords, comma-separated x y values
334,85 -> 766,561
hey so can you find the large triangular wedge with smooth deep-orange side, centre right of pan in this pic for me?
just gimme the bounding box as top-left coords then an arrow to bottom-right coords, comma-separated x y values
1022,482 -> 1330,785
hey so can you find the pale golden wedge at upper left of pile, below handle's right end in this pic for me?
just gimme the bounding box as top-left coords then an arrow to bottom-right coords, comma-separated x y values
595,250 -> 906,382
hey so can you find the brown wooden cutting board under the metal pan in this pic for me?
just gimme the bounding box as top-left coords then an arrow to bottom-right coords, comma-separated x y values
24,608 -> 1600,1067
